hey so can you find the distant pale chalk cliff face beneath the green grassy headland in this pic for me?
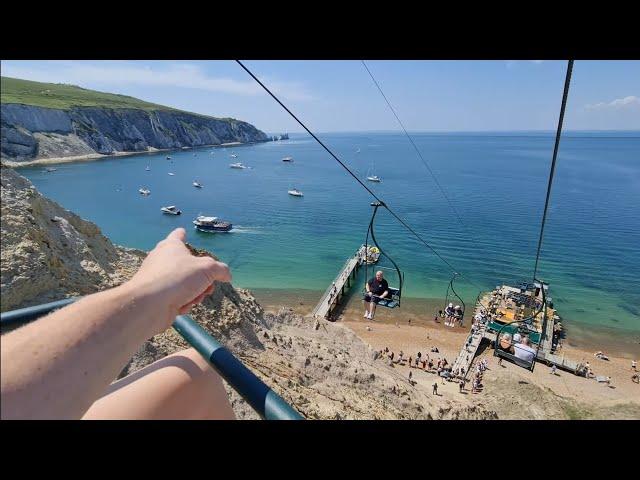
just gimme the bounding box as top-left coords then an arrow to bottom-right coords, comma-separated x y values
0,104 -> 269,162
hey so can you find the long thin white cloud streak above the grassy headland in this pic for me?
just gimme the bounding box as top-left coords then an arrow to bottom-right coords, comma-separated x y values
2,61 -> 314,101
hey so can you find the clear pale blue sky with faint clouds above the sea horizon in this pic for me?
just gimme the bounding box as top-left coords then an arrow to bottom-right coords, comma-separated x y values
0,60 -> 640,133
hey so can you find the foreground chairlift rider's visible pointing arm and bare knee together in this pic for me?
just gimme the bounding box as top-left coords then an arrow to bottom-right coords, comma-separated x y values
0,228 -> 235,419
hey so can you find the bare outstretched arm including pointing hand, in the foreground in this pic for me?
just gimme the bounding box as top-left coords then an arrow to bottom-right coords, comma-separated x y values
0,229 -> 231,419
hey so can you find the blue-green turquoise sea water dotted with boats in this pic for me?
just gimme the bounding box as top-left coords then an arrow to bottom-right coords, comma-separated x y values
20,132 -> 640,333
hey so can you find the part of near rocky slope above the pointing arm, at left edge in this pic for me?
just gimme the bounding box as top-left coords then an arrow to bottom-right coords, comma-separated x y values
0,167 -> 145,311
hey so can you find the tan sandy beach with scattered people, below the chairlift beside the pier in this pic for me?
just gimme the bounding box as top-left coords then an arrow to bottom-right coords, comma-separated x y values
257,291 -> 640,419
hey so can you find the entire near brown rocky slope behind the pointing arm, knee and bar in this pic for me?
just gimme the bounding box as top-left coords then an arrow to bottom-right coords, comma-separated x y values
0,167 -> 496,419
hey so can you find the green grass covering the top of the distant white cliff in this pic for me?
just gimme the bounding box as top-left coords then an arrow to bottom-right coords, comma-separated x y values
0,77 -> 237,122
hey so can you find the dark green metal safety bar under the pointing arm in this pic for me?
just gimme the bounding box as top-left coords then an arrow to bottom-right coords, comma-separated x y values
0,297 -> 303,420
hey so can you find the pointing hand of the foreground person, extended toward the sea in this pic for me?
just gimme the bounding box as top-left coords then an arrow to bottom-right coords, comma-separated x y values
125,228 -> 231,328
